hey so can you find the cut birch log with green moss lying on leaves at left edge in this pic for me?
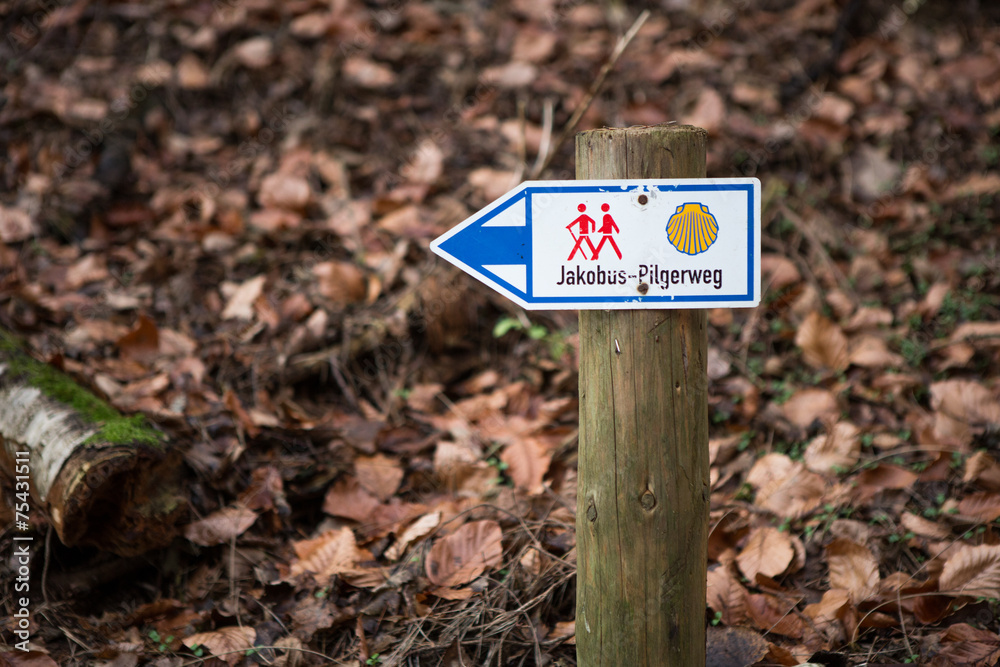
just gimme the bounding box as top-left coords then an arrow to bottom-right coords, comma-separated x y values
0,330 -> 187,556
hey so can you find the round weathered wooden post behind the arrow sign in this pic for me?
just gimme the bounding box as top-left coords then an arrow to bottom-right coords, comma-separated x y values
576,125 -> 709,667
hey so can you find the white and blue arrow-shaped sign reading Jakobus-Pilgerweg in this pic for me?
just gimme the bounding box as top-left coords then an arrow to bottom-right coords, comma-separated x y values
431,178 -> 760,310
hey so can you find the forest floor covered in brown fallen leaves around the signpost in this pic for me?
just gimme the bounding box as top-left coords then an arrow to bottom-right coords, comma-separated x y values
0,0 -> 1000,667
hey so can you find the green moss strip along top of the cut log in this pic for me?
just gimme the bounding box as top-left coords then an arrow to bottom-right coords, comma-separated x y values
0,330 -> 163,445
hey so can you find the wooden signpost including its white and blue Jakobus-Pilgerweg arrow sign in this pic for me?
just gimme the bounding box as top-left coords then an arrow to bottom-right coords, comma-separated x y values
431,125 -> 760,667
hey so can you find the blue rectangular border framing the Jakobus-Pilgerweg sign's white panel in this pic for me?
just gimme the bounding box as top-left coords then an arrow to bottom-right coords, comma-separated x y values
512,183 -> 755,305
